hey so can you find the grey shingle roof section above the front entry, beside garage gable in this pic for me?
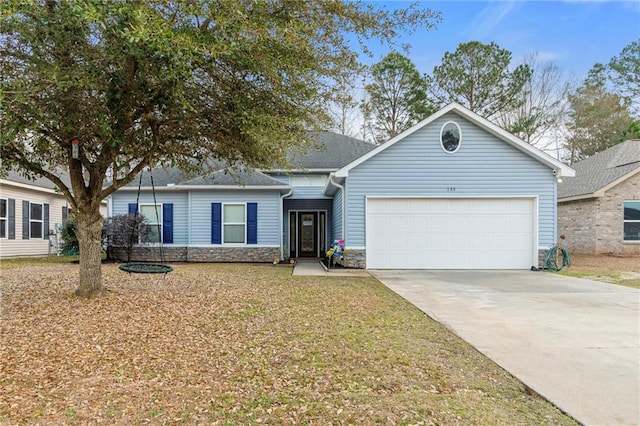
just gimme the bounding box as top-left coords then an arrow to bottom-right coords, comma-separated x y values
282,131 -> 376,171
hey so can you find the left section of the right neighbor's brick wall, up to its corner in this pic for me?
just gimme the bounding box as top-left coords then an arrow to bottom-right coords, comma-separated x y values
558,198 -> 600,254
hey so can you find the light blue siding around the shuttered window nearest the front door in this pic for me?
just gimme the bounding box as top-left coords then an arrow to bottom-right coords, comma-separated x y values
190,190 -> 280,247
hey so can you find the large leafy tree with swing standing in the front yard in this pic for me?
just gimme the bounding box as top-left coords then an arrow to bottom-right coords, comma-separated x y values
0,0 -> 439,296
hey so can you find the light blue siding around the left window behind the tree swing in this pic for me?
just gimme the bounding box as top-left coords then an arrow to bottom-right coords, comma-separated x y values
111,191 -> 189,245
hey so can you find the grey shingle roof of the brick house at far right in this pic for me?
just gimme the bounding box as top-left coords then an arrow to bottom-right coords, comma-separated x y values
558,139 -> 640,201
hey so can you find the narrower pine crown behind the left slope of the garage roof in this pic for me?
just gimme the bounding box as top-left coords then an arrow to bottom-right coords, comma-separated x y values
363,51 -> 435,143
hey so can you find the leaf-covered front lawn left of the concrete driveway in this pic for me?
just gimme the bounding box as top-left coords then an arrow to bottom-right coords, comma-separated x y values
0,264 -> 575,425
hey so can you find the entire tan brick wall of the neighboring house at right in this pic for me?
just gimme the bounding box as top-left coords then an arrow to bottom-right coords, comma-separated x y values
558,174 -> 640,255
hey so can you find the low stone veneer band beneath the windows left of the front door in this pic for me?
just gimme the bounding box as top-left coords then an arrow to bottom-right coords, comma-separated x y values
107,246 -> 280,263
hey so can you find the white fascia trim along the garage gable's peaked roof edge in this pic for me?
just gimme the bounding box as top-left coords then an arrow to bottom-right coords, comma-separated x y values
335,102 -> 576,177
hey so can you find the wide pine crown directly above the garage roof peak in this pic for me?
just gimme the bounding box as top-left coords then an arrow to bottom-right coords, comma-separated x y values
428,41 -> 531,119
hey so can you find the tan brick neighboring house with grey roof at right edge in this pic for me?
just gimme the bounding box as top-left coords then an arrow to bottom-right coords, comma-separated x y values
558,140 -> 640,255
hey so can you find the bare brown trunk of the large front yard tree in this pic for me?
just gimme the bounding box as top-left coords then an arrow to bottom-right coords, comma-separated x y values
75,208 -> 103,297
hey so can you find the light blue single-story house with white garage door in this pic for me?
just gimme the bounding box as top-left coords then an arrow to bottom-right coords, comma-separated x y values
109,104 -> 574,269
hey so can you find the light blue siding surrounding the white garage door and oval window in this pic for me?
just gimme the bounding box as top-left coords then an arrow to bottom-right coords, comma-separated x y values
342,113 -> 556,247
